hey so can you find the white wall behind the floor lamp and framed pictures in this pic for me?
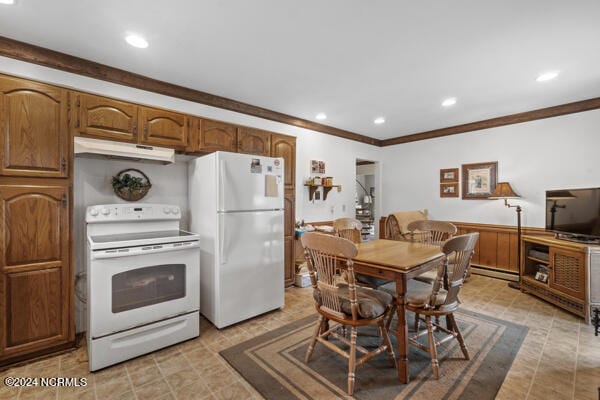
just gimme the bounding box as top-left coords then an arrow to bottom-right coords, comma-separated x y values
382,110 -> 600,227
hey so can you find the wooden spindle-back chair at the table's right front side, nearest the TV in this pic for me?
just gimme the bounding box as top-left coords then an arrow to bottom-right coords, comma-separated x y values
406,233 -> 479,379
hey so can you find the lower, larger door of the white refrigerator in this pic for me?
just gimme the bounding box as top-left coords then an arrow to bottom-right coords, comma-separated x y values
212,211 -> 284,328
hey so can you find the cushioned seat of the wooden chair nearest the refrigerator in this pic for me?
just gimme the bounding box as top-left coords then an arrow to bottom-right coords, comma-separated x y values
313,284 -> 393,319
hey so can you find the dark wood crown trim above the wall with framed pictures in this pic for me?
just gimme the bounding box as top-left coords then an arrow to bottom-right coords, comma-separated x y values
381,97 -> 600,147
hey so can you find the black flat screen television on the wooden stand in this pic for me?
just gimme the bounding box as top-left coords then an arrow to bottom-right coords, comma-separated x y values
546,188 -> 600,242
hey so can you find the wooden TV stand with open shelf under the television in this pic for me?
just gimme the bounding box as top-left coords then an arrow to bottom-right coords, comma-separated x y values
520,235 -> 600,323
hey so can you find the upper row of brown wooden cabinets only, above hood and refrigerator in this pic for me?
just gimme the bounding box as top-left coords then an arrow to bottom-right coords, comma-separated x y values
0,75 -> 296,188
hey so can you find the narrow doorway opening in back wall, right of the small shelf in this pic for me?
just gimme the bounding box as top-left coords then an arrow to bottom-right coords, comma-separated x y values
354,158 -> 378,242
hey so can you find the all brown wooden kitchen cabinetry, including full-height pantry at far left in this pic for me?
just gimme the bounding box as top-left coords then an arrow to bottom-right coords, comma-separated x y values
0,74 -> 296,366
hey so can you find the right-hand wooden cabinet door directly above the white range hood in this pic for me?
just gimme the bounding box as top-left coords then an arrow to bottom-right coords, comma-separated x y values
140,107 -> 188,150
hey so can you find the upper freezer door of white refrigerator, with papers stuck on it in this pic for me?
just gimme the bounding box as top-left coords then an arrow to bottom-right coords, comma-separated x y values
217,152 -> 284,211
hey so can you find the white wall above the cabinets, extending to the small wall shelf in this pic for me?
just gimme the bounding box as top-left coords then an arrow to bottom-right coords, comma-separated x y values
0,57 -> 380,225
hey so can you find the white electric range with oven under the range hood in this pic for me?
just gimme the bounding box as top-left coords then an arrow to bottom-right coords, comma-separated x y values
86,204 -> 200,371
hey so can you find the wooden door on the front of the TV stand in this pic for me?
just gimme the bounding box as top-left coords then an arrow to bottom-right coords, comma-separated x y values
548,247 -> 585,300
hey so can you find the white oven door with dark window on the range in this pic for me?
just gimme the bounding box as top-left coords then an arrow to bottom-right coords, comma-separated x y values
88,243 -> 200,338
